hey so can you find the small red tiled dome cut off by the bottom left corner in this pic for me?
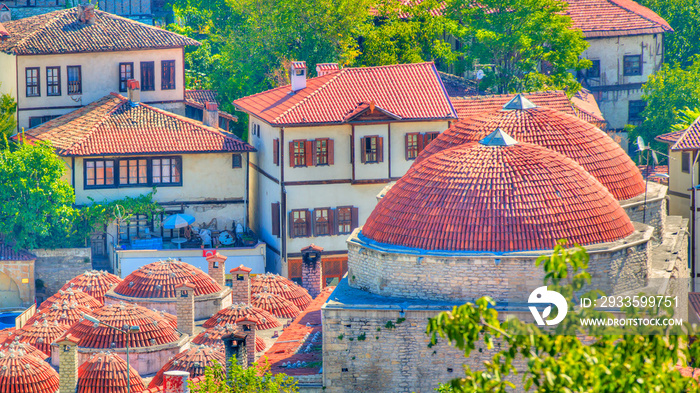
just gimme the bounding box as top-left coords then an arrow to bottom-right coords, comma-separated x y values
0,350 -> 59,393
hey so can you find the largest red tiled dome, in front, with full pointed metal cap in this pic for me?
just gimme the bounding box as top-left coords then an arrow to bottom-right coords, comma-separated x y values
361,130 -> 634,252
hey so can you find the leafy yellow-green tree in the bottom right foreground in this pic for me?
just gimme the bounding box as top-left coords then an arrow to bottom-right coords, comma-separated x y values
427,242 -> 699,393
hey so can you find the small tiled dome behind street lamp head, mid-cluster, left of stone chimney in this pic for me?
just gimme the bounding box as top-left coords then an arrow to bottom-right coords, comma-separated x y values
67,303 -> 180,349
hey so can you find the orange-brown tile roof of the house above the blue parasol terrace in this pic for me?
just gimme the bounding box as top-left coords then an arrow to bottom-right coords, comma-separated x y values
26,93 -> 255,156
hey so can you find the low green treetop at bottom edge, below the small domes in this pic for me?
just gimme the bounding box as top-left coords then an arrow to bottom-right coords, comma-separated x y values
189,356 -> 299,393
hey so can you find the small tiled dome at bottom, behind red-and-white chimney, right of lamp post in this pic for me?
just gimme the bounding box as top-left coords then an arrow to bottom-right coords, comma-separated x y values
148,345 -> 226,393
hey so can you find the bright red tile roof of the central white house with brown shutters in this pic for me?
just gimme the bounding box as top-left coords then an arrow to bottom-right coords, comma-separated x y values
233,63 -> 456,126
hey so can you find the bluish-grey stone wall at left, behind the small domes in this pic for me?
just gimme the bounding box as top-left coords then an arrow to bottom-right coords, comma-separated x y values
31,248 -> 92,300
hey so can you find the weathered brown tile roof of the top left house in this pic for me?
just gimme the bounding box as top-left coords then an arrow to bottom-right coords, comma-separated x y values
0,8 -> 199,55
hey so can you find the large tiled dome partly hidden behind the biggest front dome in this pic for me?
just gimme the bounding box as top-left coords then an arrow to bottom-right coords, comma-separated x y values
416,96 -> 644,200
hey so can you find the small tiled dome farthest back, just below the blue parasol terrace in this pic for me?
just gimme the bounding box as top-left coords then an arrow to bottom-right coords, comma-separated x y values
114,259 -> 223,298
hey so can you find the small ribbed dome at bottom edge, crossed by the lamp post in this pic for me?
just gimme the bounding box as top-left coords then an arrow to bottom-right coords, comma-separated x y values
76,352 -> 146,393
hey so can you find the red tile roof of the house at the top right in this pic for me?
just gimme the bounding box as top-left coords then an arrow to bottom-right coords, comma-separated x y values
565,0 -> 673,38
